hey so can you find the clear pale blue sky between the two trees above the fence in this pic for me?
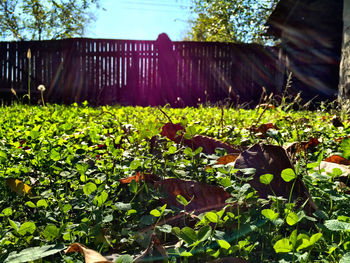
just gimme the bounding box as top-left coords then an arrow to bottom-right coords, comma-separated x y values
85,0 -> 191,41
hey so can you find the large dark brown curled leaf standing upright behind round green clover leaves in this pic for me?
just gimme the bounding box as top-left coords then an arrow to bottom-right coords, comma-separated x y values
234,144 -> 317,213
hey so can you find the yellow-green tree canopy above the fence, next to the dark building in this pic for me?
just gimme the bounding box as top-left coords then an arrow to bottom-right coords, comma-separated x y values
188,0 -> 279,43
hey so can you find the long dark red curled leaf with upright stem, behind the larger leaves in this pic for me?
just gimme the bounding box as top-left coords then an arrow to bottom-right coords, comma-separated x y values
160,123 -> 240,154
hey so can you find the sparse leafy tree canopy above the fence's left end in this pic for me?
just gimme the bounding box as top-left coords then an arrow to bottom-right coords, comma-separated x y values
0,0 -> 99,40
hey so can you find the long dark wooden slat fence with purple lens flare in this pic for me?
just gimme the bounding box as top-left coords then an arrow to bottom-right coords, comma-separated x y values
0,37 -> 284,107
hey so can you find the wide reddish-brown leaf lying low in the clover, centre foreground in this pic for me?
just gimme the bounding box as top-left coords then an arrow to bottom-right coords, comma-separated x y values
155,178 -> 230,215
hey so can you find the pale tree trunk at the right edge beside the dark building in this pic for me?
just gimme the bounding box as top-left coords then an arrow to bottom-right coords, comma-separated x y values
339,0 -> 350,99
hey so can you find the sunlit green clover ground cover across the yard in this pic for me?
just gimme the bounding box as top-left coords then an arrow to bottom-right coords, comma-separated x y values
0,105 -> 350,262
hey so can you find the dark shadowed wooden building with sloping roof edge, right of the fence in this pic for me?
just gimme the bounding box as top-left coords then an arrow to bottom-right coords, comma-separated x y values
267,0 -> 347,100
